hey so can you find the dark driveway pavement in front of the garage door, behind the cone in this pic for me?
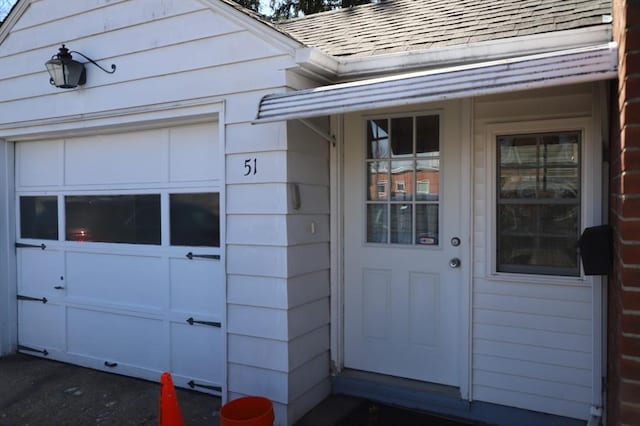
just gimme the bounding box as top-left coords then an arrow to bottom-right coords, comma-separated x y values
0,354 -> 220,426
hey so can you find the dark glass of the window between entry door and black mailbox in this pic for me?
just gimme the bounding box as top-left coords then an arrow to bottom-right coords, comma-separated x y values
497,132 -> 580,276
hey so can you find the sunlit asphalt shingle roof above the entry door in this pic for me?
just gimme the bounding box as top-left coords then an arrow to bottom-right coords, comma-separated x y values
276,0 -> 611,56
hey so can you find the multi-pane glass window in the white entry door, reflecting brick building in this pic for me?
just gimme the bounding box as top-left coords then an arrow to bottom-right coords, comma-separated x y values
366,115 -> 440,245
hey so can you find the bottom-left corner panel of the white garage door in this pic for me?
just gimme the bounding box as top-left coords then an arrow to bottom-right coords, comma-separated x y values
18,301 -> 65,351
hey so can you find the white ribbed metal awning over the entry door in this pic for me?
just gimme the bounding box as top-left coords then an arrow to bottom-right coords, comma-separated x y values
255,43 -> 618,123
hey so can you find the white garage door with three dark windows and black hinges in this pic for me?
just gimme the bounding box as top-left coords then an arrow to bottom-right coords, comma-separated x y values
16,124 -> 225,393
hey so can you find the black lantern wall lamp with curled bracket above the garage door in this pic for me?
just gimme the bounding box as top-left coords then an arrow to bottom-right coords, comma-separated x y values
44,44 -> 116,89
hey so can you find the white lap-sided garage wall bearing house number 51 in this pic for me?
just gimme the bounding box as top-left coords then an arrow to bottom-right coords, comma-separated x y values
0,0 -> 329,424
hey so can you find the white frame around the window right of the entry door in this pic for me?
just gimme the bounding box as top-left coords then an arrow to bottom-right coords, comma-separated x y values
485,118 -> 602,285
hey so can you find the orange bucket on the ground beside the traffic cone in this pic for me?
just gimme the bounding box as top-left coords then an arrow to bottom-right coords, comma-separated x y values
220,396 -> 275,426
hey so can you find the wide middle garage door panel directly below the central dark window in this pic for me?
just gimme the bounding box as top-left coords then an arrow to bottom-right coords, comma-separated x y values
67,252 -> 167,308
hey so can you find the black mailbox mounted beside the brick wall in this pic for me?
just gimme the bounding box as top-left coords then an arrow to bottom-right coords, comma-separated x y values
578,225 -> 613,275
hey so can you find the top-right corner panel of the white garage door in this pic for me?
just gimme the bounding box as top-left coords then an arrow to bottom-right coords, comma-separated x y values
169,125 -> 221,182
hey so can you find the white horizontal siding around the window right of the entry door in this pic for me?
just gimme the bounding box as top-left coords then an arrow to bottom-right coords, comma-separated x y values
472,85 -> 593,419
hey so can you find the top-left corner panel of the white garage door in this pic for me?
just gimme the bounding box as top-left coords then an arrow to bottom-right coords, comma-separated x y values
16,140 -> 64,188
